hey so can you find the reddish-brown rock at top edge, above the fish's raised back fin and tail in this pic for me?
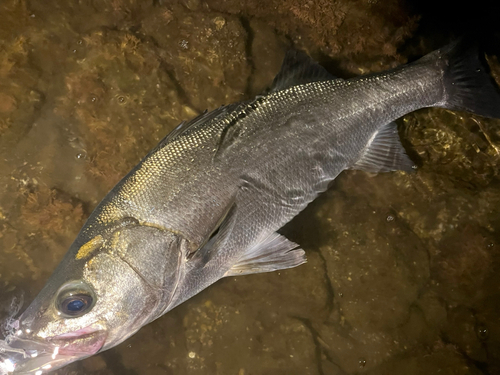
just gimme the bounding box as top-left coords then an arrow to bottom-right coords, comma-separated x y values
203,0 -> 418,74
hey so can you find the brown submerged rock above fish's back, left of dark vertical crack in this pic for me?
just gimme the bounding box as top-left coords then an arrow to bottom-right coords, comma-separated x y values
143,6 -> 250,110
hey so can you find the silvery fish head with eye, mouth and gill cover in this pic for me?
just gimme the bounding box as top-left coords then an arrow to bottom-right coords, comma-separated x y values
2,225 -> 183,375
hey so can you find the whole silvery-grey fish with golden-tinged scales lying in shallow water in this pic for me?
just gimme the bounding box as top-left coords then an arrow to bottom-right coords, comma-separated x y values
0,40 -> 500,375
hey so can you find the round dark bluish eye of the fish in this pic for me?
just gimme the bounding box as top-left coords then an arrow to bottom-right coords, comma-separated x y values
56,281 -> 95,318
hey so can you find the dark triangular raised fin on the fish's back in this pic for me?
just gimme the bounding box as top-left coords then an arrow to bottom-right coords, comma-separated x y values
270,50 -> 340,92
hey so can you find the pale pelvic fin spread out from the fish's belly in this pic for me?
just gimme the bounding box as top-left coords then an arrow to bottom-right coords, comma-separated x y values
224,233 -> 306,276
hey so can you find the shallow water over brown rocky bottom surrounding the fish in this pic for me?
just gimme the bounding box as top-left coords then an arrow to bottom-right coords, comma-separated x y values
0,0 -> 500,375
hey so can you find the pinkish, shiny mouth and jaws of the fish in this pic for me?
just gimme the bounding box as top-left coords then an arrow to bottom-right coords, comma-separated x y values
0,326 -> 107,375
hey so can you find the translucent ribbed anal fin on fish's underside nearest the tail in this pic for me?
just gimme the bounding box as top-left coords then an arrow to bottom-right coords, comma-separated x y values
350,122 -> 415,173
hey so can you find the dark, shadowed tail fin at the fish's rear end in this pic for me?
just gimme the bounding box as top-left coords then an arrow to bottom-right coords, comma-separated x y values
439,40 -> 500,118
